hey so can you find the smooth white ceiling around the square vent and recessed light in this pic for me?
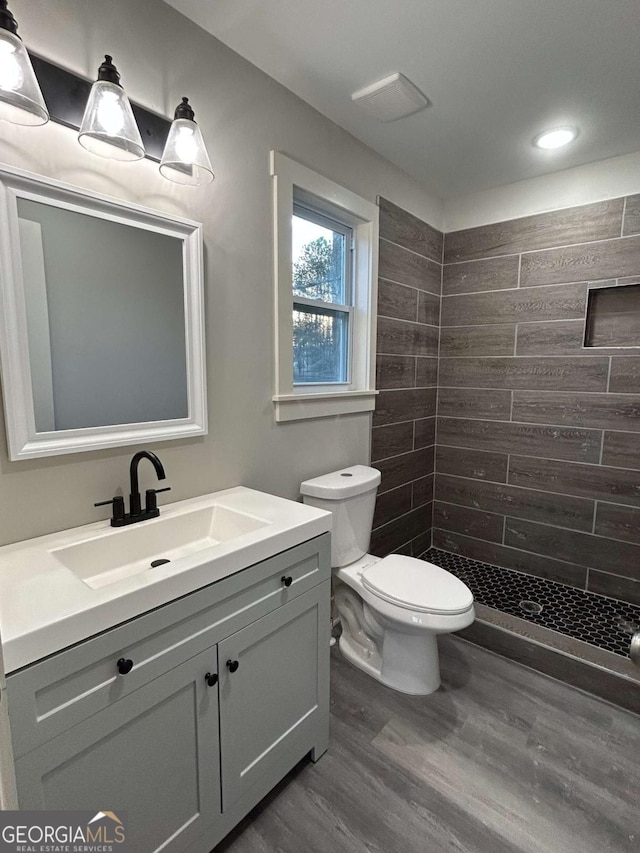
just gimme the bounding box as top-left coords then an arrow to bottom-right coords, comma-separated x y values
162,0 -> 640,198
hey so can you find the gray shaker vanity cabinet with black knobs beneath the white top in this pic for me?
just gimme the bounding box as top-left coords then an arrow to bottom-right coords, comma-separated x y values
7,534 -> 330,853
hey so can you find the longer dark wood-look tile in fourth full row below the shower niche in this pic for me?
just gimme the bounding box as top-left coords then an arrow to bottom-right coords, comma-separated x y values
509,456 -> 640,507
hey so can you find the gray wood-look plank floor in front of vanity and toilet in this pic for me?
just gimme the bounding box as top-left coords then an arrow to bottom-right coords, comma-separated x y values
215,637 -> 640,853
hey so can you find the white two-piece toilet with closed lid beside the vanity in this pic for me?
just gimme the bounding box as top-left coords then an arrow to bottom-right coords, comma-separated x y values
300,465 -> 475,695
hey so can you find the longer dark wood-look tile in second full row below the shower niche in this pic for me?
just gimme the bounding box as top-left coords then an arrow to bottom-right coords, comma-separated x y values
512,392 -> 640,432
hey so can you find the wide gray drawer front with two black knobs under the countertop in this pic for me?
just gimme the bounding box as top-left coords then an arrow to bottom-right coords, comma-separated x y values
7,534 -> 331,757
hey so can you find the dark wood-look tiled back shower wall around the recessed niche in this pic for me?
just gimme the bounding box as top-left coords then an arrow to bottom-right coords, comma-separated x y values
433,195 -> 640,602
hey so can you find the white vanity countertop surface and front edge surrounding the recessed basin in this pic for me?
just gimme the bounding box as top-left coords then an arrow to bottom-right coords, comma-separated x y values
0,486 -> 331,676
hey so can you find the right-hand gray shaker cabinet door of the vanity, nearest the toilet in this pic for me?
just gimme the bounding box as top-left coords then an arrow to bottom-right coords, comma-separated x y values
218,582 -> 330,812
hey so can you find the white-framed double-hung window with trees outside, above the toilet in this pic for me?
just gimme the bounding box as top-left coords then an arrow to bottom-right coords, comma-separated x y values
271,152 -> 378,421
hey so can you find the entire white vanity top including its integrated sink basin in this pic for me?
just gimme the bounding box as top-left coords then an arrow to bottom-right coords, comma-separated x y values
0,486 -> 331,672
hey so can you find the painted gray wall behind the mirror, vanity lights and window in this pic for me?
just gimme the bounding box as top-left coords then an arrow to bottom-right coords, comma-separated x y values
0,0 -> 441,543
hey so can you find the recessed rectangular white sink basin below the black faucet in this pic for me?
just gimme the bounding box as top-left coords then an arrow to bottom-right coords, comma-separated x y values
49,506 -> 269,589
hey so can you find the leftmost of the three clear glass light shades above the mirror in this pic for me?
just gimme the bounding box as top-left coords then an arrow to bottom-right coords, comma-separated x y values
0,29 -> 49,126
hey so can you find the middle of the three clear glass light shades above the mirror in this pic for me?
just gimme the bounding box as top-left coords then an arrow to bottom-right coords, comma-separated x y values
78,80 -> 144,160
